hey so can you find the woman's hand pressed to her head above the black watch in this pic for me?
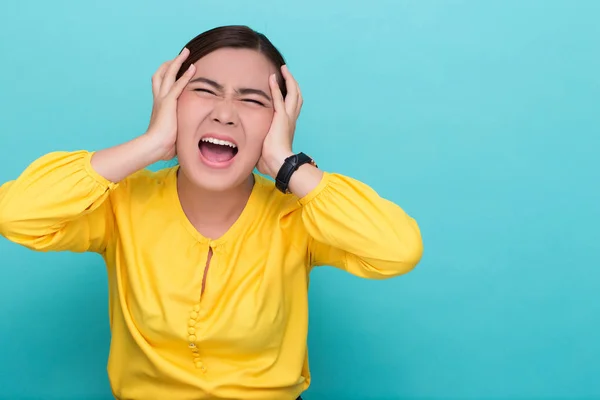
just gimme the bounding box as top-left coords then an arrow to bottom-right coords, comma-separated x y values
256,65 -> 302,179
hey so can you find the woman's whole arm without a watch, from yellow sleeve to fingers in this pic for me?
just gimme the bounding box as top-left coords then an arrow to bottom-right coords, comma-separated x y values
0,49 -> 194,252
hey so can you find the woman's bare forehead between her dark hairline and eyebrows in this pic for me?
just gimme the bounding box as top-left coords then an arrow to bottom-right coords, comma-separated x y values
194,48 -> 275,85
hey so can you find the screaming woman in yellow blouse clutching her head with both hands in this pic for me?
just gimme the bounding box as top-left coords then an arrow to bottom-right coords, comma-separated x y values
0,26 -> 422,400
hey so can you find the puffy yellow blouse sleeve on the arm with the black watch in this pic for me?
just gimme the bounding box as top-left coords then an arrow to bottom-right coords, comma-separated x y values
299,173 -> 423,279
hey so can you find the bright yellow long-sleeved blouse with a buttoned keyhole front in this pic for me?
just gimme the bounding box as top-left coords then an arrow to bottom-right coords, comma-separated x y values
0,151 -> 423,400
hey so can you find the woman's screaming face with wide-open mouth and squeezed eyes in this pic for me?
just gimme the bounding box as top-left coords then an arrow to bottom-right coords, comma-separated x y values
176,48 -> 276,191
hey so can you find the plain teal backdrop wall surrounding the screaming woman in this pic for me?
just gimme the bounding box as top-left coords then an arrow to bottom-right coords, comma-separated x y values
0,0 -> 600,400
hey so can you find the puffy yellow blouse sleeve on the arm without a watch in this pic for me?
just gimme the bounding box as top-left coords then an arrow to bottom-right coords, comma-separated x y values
0,151 -> 117,252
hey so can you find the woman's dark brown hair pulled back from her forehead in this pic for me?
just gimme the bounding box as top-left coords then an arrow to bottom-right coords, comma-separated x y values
177,25 -> 287,97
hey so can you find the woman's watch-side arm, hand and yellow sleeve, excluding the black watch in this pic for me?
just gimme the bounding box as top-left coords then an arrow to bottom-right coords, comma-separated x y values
258,67 -> 423,279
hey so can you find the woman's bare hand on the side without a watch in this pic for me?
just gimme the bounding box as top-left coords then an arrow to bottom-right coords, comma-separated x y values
145,48 -> 195,161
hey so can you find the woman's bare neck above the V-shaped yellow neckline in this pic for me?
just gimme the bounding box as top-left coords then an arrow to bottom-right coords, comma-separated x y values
177,171 -> 254,239
